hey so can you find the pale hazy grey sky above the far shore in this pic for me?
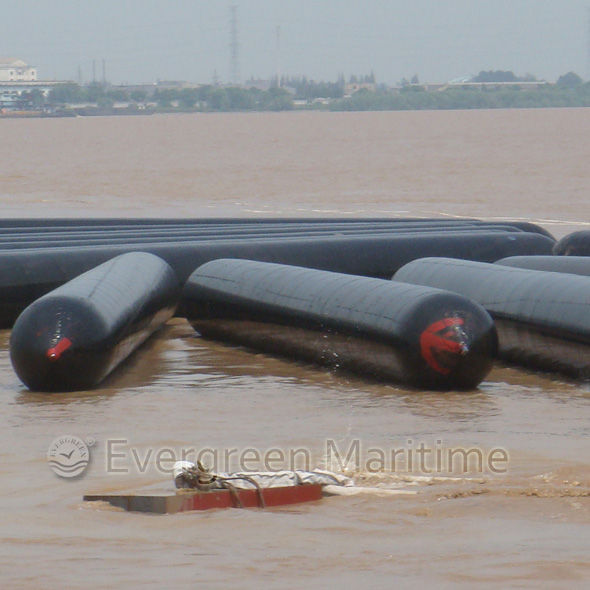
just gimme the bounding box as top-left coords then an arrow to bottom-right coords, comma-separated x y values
0,0 -> 590,84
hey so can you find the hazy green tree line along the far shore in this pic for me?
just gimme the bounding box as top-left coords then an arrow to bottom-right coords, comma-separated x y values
37,71 -> 590,112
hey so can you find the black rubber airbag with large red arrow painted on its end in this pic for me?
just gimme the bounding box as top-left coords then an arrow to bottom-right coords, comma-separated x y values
183,259 -> 497,390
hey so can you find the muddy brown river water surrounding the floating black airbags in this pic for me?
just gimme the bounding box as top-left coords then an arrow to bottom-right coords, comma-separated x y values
0,109 -> 590,590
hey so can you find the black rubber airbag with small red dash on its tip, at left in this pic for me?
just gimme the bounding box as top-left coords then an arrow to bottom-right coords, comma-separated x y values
10,252 -> 180,391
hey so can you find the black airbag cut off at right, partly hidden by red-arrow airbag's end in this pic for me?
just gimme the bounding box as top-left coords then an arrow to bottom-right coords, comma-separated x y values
394,258 -> 590,379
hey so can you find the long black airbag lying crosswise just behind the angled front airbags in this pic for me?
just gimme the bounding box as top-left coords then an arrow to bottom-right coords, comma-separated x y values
0,229 -> 553,328
